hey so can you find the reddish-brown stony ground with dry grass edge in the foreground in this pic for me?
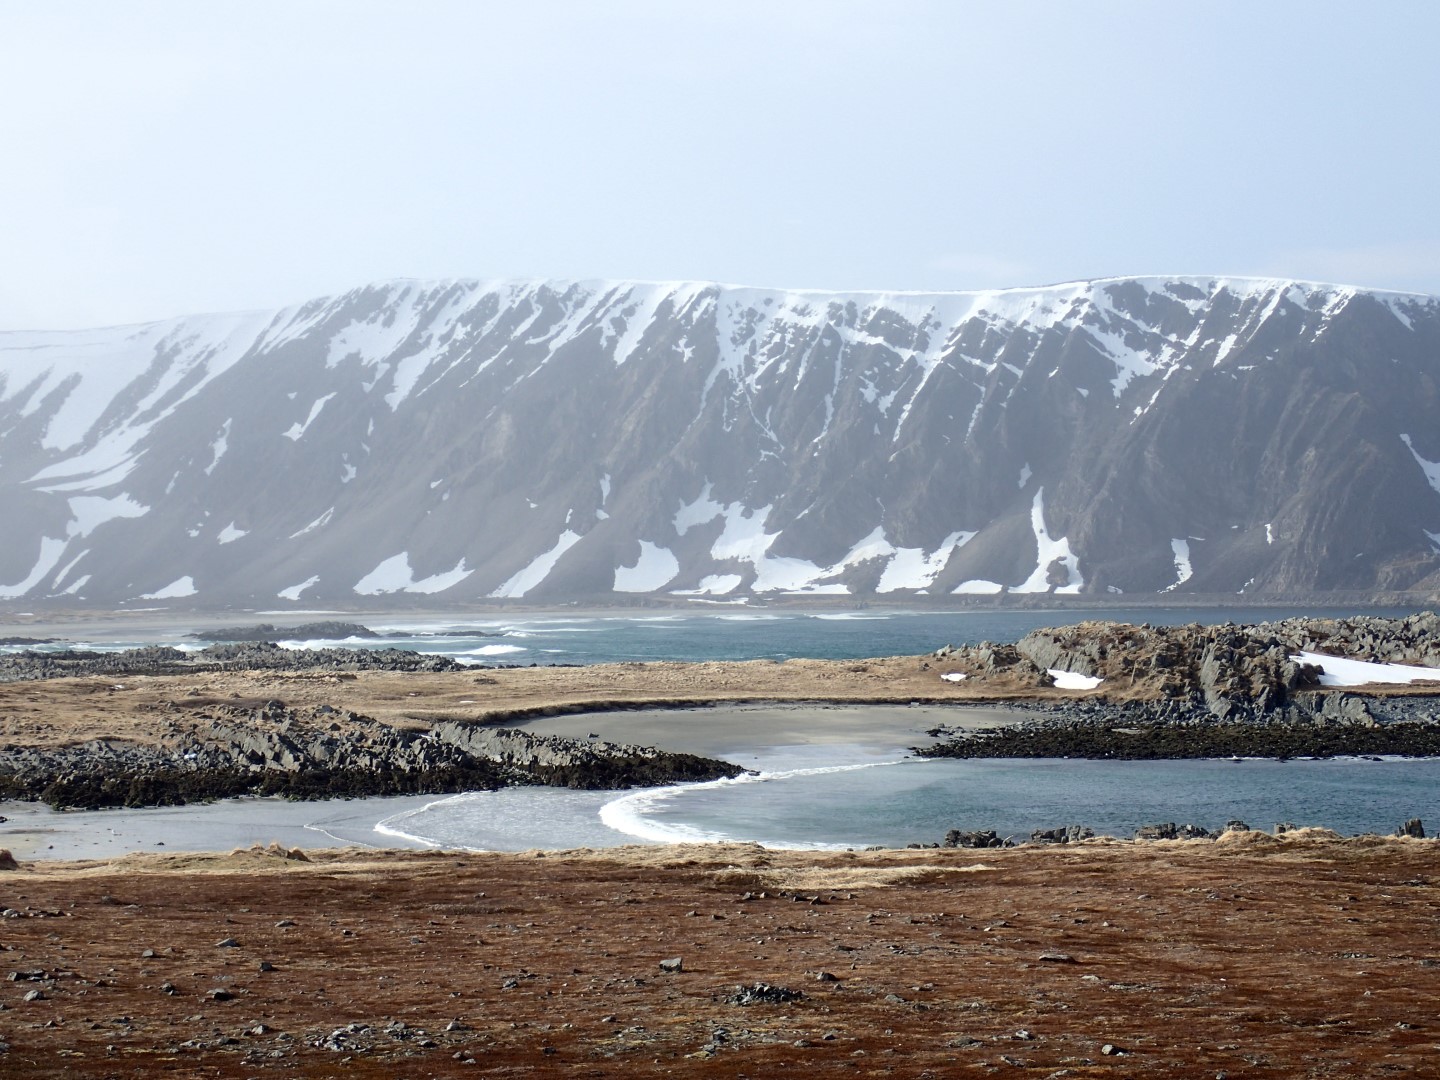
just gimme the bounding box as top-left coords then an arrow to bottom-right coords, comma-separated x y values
0,831 -> 1440,1080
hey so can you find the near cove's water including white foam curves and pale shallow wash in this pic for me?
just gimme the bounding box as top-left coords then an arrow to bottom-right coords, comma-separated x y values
380,743 -> 1440,850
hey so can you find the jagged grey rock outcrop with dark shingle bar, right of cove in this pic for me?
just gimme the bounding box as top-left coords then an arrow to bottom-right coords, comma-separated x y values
916,612 -> 1440,760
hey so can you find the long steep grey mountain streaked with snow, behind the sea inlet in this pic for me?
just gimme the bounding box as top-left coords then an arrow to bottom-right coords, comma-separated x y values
0,278 -> 1440,609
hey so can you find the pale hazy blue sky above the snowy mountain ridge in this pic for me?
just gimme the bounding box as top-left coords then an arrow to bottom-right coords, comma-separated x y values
0,0 -> 1440,328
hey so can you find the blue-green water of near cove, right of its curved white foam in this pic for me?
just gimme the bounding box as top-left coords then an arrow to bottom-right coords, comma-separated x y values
619,759 -> 1440,847
